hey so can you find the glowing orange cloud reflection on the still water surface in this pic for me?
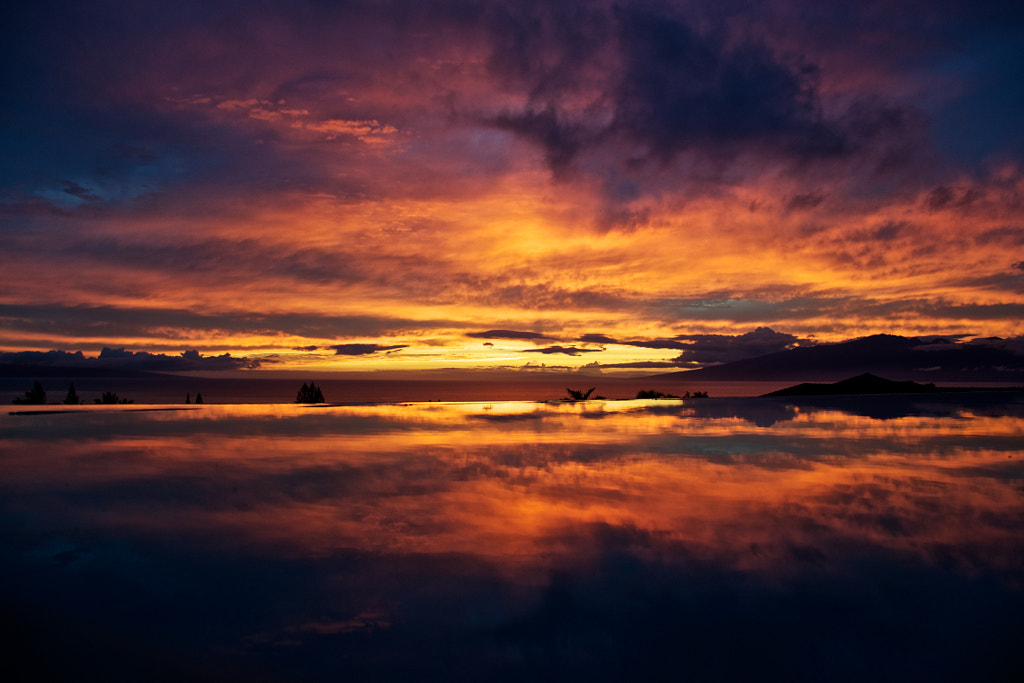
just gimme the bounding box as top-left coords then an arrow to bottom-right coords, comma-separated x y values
2,401 -> 1024,580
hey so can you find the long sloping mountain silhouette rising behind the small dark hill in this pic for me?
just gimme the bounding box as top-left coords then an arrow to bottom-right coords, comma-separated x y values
652,335 -> 1024,382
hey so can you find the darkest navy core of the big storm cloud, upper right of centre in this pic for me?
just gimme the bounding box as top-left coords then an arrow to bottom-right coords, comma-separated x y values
612,8 -> 844,162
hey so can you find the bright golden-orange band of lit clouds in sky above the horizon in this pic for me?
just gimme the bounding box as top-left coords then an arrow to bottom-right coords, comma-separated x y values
0,144 -> 1024,370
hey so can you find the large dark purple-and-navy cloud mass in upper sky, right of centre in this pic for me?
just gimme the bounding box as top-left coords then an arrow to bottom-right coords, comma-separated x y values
492,3 -> 926,180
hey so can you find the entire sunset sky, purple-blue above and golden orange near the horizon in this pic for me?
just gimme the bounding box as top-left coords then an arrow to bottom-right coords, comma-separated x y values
0,0 -> 1024,373
